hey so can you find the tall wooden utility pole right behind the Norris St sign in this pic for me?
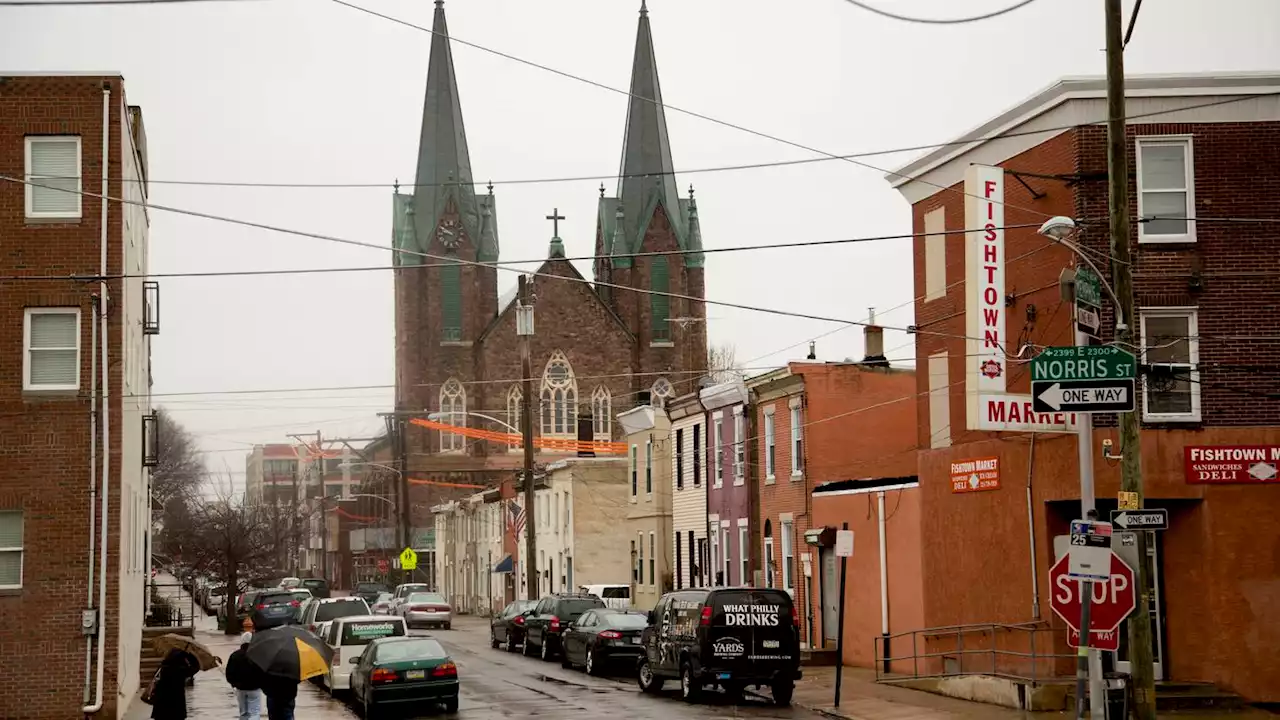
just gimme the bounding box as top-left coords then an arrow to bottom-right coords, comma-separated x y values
1103,0 -> 1156,720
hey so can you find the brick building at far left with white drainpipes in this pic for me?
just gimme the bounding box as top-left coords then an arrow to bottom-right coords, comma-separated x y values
0,73 -> 159,719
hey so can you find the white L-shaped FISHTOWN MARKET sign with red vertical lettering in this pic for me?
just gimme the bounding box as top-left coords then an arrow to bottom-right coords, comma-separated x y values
964,165 -> 1075,433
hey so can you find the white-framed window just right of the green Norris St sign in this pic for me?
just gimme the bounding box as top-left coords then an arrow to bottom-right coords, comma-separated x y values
1142,309 -> 1201,423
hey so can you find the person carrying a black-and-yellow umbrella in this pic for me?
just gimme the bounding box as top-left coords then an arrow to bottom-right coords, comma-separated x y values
244,625 -> 333,720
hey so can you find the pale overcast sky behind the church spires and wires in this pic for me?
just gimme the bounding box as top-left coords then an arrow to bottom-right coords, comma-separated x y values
0,0 -> 1280,481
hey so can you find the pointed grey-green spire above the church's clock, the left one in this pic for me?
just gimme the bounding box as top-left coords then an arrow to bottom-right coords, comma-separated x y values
413,0 -> 480,250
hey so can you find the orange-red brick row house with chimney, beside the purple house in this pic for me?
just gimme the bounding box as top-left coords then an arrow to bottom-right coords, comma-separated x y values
746,327 -> 919,661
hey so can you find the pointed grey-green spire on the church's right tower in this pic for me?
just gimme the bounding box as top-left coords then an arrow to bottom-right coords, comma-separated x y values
618,0 -> 684,243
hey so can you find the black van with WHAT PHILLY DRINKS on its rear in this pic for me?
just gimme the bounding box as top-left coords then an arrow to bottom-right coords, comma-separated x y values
636,588 -> 801,706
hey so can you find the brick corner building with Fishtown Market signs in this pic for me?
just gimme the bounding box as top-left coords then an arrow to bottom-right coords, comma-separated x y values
890,73 -> 1280,702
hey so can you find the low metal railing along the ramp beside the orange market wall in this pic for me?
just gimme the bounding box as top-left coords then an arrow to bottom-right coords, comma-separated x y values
874,623 -> 1075,684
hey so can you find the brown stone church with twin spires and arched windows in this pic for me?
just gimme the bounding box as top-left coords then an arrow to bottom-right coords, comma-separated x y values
393,0 -> 708,504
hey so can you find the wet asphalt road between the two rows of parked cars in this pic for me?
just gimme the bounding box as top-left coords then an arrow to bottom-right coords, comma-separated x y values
298,618 -> 822,720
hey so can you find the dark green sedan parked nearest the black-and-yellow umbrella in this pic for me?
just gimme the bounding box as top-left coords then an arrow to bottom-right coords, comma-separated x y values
351,637 -> 458,720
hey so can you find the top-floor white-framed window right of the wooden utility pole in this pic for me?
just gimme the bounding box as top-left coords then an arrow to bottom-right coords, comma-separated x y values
1138,137 -> 1196,242
